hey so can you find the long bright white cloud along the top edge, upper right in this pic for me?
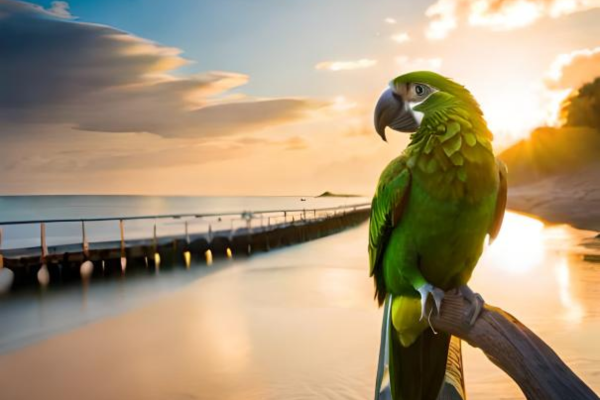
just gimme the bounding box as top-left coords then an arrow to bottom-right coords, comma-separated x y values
425,0 -> 600,40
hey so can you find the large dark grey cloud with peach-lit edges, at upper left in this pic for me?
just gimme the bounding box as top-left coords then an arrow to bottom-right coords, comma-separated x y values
0,0 -> 323,138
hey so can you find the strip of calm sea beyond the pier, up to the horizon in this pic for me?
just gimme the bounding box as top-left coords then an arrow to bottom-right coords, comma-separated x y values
0,196 -> 368,249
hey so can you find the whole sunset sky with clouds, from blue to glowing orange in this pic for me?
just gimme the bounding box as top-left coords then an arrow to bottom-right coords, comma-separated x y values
0,0 -> 600,196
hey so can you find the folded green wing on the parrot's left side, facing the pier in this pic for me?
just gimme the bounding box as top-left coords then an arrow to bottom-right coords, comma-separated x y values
369,156 -> 411,305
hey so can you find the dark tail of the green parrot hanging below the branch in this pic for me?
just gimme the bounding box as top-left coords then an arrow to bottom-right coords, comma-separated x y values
388,324 -> 451,400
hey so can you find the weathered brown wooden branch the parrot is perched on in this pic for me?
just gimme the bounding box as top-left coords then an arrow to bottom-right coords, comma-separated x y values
431,292 -> 598,400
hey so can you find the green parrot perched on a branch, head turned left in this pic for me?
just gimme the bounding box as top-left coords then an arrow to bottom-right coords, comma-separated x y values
369,71 -> 507,400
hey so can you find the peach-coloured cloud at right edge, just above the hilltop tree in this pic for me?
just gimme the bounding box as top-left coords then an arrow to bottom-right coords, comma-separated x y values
545,47 -> 600,90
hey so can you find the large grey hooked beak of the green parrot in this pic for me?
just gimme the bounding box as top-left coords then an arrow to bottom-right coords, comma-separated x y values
375,88 -> 419,141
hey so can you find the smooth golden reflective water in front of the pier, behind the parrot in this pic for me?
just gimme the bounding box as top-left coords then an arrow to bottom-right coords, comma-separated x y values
0,206 -> 600,400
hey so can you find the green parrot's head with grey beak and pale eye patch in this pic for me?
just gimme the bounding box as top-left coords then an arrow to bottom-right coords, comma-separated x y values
375,71 -> 481,140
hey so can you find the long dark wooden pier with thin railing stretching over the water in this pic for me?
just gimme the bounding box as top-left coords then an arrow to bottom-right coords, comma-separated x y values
0,203 -> 370,289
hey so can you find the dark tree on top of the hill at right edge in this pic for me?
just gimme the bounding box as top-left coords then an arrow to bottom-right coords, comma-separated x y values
561,77 -> 600,131
